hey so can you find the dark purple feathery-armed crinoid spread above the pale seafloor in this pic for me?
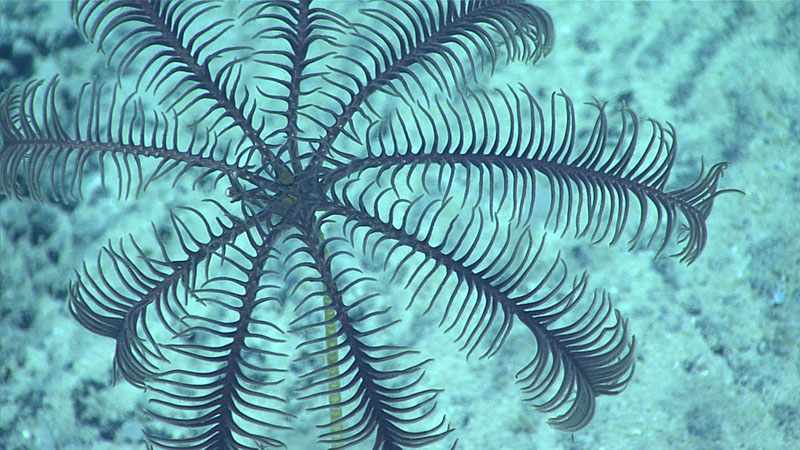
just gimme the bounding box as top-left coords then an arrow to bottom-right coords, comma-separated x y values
0,0 -> 736,449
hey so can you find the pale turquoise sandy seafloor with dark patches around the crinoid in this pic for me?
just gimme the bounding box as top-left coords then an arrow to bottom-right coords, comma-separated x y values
0,1 -> 800,450
